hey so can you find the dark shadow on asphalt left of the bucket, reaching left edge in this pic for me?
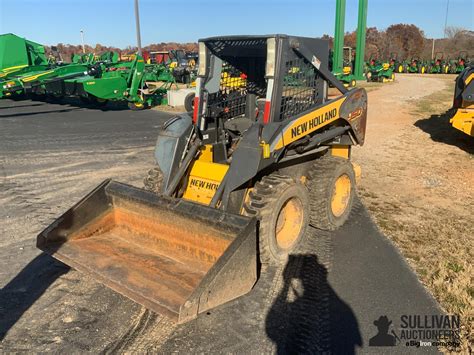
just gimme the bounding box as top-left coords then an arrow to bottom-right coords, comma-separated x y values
0,253 -> 69,341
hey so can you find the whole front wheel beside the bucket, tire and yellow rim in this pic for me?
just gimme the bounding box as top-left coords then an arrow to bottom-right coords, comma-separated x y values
244,174 -> 310,265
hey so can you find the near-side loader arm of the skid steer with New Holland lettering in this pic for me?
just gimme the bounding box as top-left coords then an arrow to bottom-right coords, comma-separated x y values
217,89 -> 367,210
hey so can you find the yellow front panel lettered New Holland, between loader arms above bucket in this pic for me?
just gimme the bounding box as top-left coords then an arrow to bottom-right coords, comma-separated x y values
183,159 -> 229,205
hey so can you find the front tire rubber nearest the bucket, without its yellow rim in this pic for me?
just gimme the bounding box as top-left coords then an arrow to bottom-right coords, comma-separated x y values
244,173 -> 310,265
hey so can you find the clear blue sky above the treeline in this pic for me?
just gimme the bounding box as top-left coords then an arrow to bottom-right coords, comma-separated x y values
0,0 -> 474,48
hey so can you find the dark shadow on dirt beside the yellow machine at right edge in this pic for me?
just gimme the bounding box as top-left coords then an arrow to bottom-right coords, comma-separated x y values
415,110 -> 474,154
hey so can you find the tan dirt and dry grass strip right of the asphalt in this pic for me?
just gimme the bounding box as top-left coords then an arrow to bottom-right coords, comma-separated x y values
353,75 -> 474,350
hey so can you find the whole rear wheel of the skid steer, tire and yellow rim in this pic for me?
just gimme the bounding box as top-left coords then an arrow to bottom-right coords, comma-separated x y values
307,156 -> 356,231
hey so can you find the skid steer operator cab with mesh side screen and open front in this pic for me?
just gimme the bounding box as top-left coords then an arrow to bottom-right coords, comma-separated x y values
193,35 -> 329,163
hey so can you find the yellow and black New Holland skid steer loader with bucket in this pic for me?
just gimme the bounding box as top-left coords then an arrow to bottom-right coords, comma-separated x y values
37,35 -> 367,322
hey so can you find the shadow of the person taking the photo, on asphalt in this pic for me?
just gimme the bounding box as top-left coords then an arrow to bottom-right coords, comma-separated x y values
265,254 -> 363,354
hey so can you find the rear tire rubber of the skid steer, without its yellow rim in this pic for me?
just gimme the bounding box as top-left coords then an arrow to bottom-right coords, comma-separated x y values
306,155 -> 356,231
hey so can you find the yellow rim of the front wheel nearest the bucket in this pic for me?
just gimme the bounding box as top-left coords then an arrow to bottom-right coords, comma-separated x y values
275,197 -> 304,250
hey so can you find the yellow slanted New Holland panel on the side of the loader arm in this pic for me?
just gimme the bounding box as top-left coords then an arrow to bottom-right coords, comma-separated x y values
272,97 -> 345,151
